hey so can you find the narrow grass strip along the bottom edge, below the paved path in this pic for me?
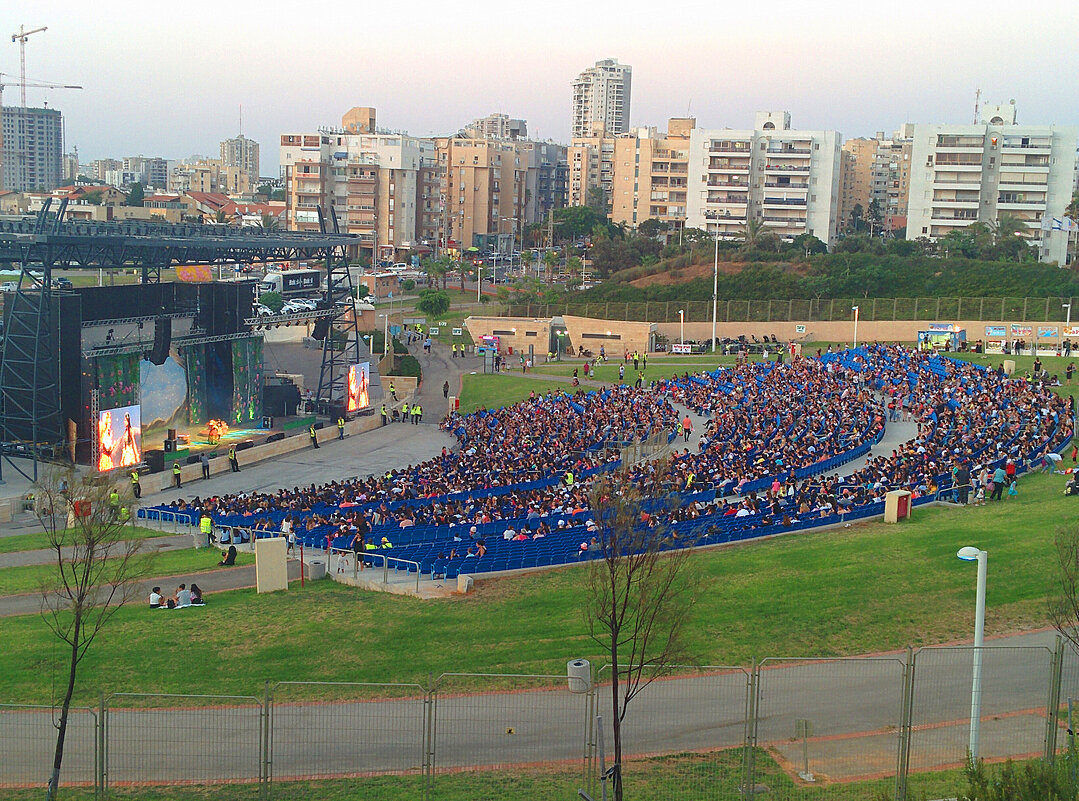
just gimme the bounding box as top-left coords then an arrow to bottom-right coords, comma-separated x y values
0,749 -> 966,801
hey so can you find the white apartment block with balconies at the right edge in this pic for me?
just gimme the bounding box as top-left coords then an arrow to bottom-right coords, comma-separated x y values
906,104 -> 1079,264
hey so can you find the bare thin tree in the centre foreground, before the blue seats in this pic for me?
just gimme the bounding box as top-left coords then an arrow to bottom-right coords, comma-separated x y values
587,464 -> 699,801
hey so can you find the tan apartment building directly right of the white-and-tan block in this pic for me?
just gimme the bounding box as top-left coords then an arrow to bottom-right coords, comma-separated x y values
435,136 -> 536,253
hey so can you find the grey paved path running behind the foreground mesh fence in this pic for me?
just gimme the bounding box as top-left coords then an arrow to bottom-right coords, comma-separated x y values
0,630 -> 1079,784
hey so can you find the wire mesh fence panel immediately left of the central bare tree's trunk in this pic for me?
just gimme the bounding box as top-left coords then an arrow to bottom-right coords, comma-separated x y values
432,674 -> 592,799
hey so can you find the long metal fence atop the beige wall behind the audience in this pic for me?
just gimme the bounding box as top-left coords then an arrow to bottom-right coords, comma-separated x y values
500,298 -> 1079,323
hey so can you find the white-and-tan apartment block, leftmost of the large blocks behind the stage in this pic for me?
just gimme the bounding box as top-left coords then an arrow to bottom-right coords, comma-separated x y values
281,116 -> 440,259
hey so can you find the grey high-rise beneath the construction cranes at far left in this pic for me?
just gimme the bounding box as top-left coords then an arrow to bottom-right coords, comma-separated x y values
0,106 -> 64,192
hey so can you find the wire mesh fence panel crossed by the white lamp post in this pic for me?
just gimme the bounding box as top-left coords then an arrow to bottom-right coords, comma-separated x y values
909,647 -> 1063,788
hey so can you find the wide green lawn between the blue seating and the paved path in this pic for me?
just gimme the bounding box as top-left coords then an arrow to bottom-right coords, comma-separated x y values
0,475 -> 1076,703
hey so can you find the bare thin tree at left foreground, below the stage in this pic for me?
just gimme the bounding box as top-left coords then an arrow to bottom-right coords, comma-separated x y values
36,469 -> 150,799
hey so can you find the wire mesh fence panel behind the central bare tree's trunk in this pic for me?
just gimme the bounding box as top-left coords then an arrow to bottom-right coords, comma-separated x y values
590,666 -> 752,799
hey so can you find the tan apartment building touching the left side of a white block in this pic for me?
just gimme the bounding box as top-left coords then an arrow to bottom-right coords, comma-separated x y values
611,118 -> 696,228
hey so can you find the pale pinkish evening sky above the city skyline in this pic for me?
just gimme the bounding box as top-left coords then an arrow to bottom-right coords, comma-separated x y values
0,0 -> 1079,176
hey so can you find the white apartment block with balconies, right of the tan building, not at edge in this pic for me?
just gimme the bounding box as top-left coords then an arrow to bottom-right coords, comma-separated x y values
686,111 -> 842,243
